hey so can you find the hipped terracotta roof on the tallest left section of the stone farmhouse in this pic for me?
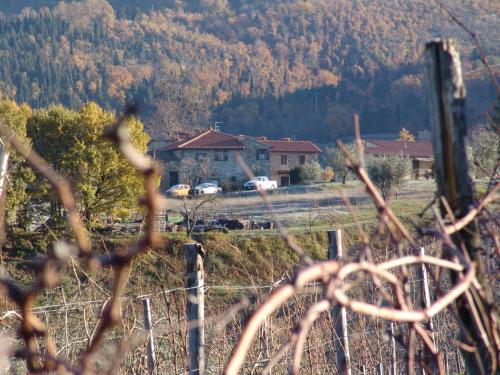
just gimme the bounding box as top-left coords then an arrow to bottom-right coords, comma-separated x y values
162,129 -> 245,151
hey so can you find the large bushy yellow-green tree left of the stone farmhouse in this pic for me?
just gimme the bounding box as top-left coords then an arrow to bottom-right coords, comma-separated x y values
28,103 -> 148,225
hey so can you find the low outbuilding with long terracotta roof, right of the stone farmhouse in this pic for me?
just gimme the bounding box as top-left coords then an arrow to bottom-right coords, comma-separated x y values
364,140 -> 434,179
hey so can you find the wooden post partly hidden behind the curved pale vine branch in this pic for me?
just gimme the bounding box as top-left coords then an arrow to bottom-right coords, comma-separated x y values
328,229 -> 351,375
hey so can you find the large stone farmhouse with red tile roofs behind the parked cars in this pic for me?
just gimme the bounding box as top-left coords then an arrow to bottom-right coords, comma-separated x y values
150,129 -> 321,188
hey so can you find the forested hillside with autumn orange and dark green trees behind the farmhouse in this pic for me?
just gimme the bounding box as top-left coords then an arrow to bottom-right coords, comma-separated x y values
0,0 -> 500,142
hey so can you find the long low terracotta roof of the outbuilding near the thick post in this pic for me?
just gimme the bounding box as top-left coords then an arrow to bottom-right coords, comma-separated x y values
365,140 -> 433,158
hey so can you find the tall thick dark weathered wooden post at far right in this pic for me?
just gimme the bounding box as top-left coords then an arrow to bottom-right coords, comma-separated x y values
426,39 -> 499,374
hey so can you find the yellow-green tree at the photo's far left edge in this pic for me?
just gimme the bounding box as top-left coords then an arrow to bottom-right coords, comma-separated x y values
0,100 -> 35,226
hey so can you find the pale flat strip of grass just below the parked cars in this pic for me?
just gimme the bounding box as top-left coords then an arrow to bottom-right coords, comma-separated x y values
167,180 -> 434,227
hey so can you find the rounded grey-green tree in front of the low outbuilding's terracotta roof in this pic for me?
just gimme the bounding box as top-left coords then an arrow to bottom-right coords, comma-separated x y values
367,155 -> 410,198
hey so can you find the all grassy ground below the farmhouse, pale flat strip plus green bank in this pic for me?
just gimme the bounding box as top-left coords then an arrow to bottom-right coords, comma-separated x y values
2,181 -> 432,298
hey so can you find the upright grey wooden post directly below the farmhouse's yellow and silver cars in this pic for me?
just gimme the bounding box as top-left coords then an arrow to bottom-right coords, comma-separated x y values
184,243 -> 205,374
